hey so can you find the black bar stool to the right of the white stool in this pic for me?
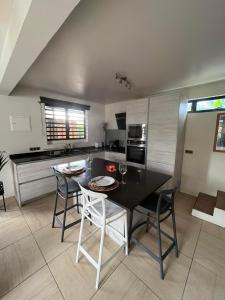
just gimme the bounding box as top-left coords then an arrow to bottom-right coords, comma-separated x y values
131,187 -> 179,279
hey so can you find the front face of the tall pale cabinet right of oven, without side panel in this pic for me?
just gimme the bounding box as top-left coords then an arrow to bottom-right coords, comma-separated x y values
147,94 -> 180,175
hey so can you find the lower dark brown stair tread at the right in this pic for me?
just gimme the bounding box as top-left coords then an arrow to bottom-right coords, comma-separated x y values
193,193 -> 217,216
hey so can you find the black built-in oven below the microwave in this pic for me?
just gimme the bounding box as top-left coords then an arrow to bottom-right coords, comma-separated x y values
126,140 -> 146,167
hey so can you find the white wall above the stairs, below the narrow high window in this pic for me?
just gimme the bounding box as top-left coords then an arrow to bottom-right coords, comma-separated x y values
181,112 -> 225,195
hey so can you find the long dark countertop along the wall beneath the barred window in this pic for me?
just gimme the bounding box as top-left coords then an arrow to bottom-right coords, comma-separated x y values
9,147 -> 125,164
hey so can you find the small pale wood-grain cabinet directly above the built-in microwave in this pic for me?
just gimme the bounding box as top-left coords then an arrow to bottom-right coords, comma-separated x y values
126,98 -> 149,125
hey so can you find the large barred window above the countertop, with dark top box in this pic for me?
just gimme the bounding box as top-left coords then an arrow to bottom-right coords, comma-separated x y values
41,97 -> 89,141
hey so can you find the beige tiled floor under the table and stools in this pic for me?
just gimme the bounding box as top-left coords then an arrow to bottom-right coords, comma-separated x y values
0,193 -> 225,300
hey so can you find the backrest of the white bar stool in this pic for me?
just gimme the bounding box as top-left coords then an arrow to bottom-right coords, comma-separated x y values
78,183 -> 108,222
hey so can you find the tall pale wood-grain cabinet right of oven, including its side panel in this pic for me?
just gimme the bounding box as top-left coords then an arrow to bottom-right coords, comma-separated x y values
147,94 -> 187,186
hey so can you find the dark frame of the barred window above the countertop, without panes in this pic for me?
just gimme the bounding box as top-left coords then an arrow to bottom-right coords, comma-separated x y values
44,105 -> 87,143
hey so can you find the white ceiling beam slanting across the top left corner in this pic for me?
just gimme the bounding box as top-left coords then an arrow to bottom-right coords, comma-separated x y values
0,0 -> 80,95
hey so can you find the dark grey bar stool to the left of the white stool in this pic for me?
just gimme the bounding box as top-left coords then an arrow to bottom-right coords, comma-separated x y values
52,169 -> 81,242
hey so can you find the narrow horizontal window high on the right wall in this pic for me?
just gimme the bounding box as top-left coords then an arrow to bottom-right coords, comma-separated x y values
188,96 -> 225,112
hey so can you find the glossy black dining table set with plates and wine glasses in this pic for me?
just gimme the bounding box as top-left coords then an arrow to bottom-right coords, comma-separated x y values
54,158 -> 171,244
